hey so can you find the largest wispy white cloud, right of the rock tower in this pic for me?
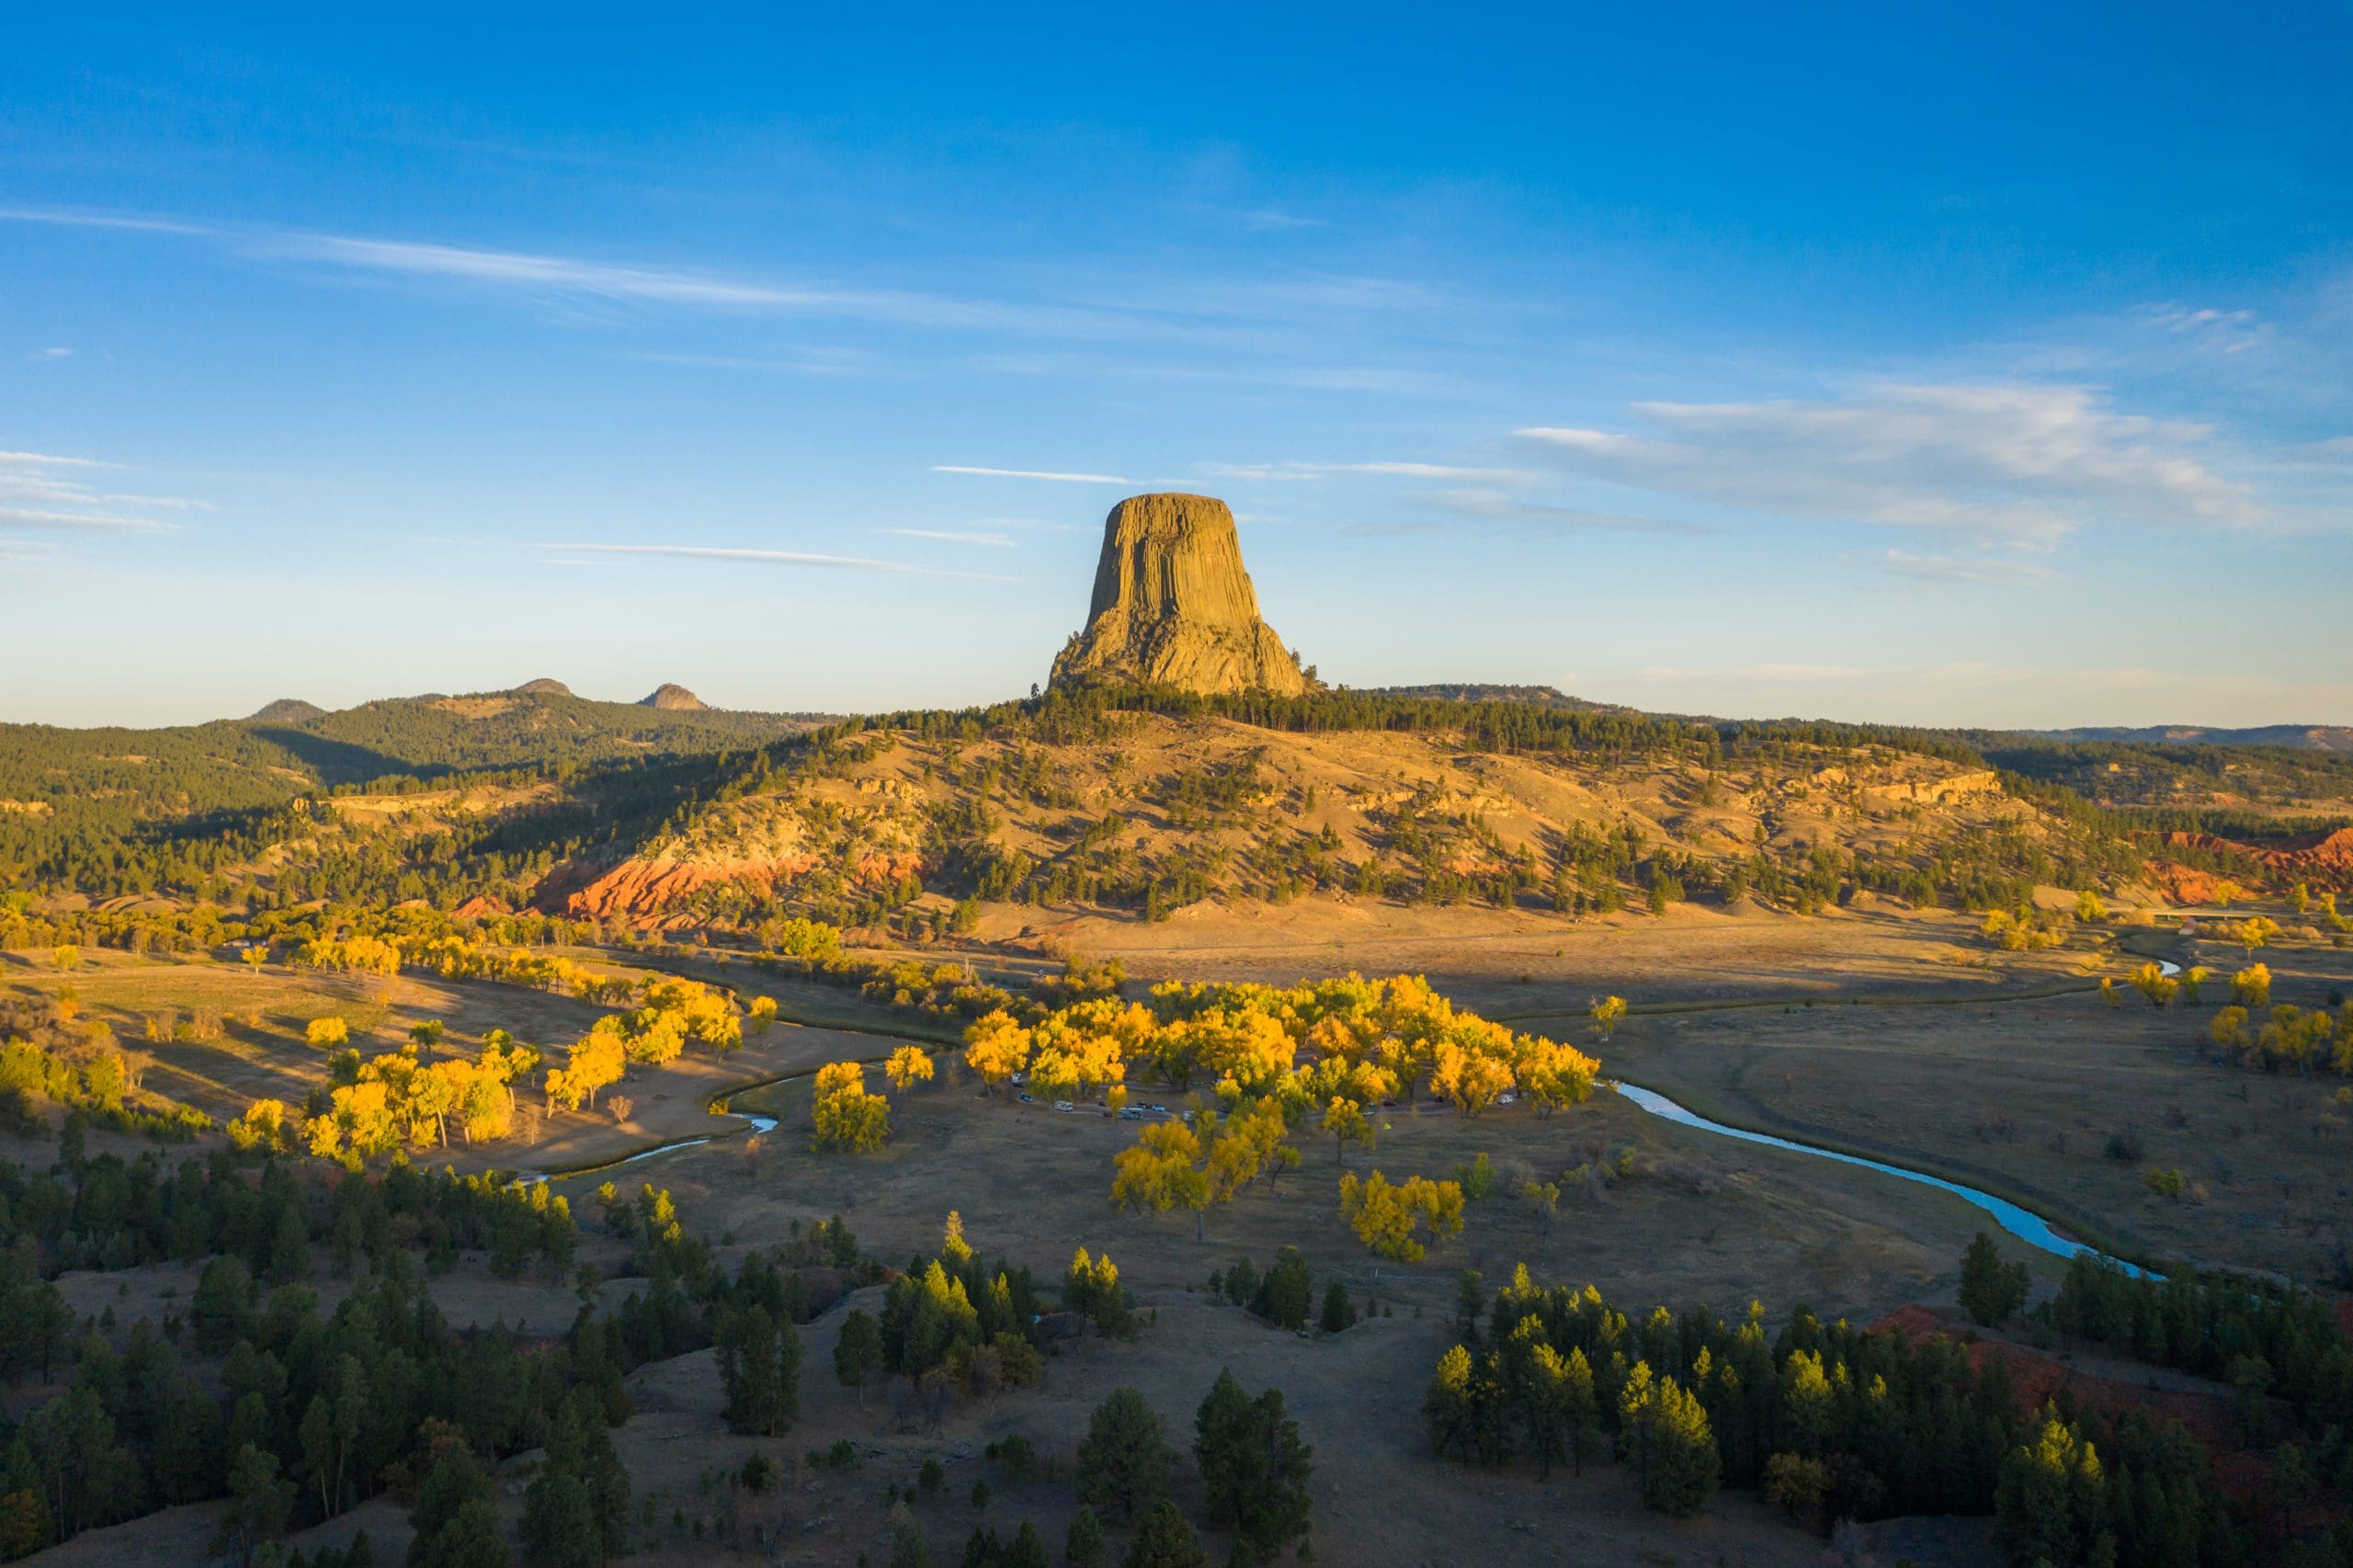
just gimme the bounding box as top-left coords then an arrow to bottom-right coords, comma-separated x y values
1518,384 -> 2273,546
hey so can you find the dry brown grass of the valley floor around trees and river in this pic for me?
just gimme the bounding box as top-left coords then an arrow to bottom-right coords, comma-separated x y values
0,904 -> 2353,1565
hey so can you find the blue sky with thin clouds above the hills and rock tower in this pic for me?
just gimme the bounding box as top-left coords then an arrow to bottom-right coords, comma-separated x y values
0,3 -> 2353,725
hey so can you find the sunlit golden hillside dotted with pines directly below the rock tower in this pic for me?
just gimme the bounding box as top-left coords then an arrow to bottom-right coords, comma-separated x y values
534,713 -> 2139,926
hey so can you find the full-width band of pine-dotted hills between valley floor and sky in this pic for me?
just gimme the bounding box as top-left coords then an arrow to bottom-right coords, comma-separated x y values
0,683 -> 2353,923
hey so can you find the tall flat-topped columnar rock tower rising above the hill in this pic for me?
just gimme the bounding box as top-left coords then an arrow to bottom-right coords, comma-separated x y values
1054,492 -> 1315,697
